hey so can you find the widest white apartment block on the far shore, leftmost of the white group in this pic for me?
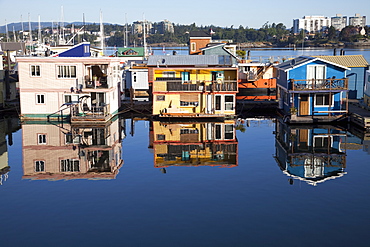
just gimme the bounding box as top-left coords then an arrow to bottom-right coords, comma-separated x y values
293,16 -> 331,33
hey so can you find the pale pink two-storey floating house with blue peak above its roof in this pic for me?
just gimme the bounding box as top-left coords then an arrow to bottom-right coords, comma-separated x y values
17,43 -> 122,123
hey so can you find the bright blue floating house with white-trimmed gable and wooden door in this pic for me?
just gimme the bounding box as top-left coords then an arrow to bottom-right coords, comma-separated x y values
275,56 -> 350,123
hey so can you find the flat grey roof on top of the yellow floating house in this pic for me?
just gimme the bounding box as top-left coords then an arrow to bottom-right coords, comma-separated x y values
148,55 -> 231,66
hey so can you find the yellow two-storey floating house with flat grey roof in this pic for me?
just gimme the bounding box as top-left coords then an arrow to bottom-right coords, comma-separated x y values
148,55 -> 238,118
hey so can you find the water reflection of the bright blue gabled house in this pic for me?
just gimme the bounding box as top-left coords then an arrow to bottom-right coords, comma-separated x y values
275,120 -> 347,186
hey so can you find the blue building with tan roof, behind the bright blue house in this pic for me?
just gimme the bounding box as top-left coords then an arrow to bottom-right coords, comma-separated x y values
314,55 -> 369,99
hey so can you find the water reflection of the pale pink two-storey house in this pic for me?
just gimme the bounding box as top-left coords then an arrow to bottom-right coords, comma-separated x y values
22,116 -> 123,180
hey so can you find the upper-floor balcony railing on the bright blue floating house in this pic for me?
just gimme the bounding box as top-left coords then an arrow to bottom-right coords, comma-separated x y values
289,78 -> 348,91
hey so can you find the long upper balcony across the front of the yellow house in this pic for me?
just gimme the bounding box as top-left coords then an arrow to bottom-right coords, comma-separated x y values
153,80 -> 238,92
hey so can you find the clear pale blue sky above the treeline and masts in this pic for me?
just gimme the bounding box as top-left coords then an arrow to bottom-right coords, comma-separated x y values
0,0 -> 370,28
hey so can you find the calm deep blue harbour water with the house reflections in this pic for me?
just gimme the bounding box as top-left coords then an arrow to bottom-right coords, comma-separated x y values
0,48 -> 370,247
